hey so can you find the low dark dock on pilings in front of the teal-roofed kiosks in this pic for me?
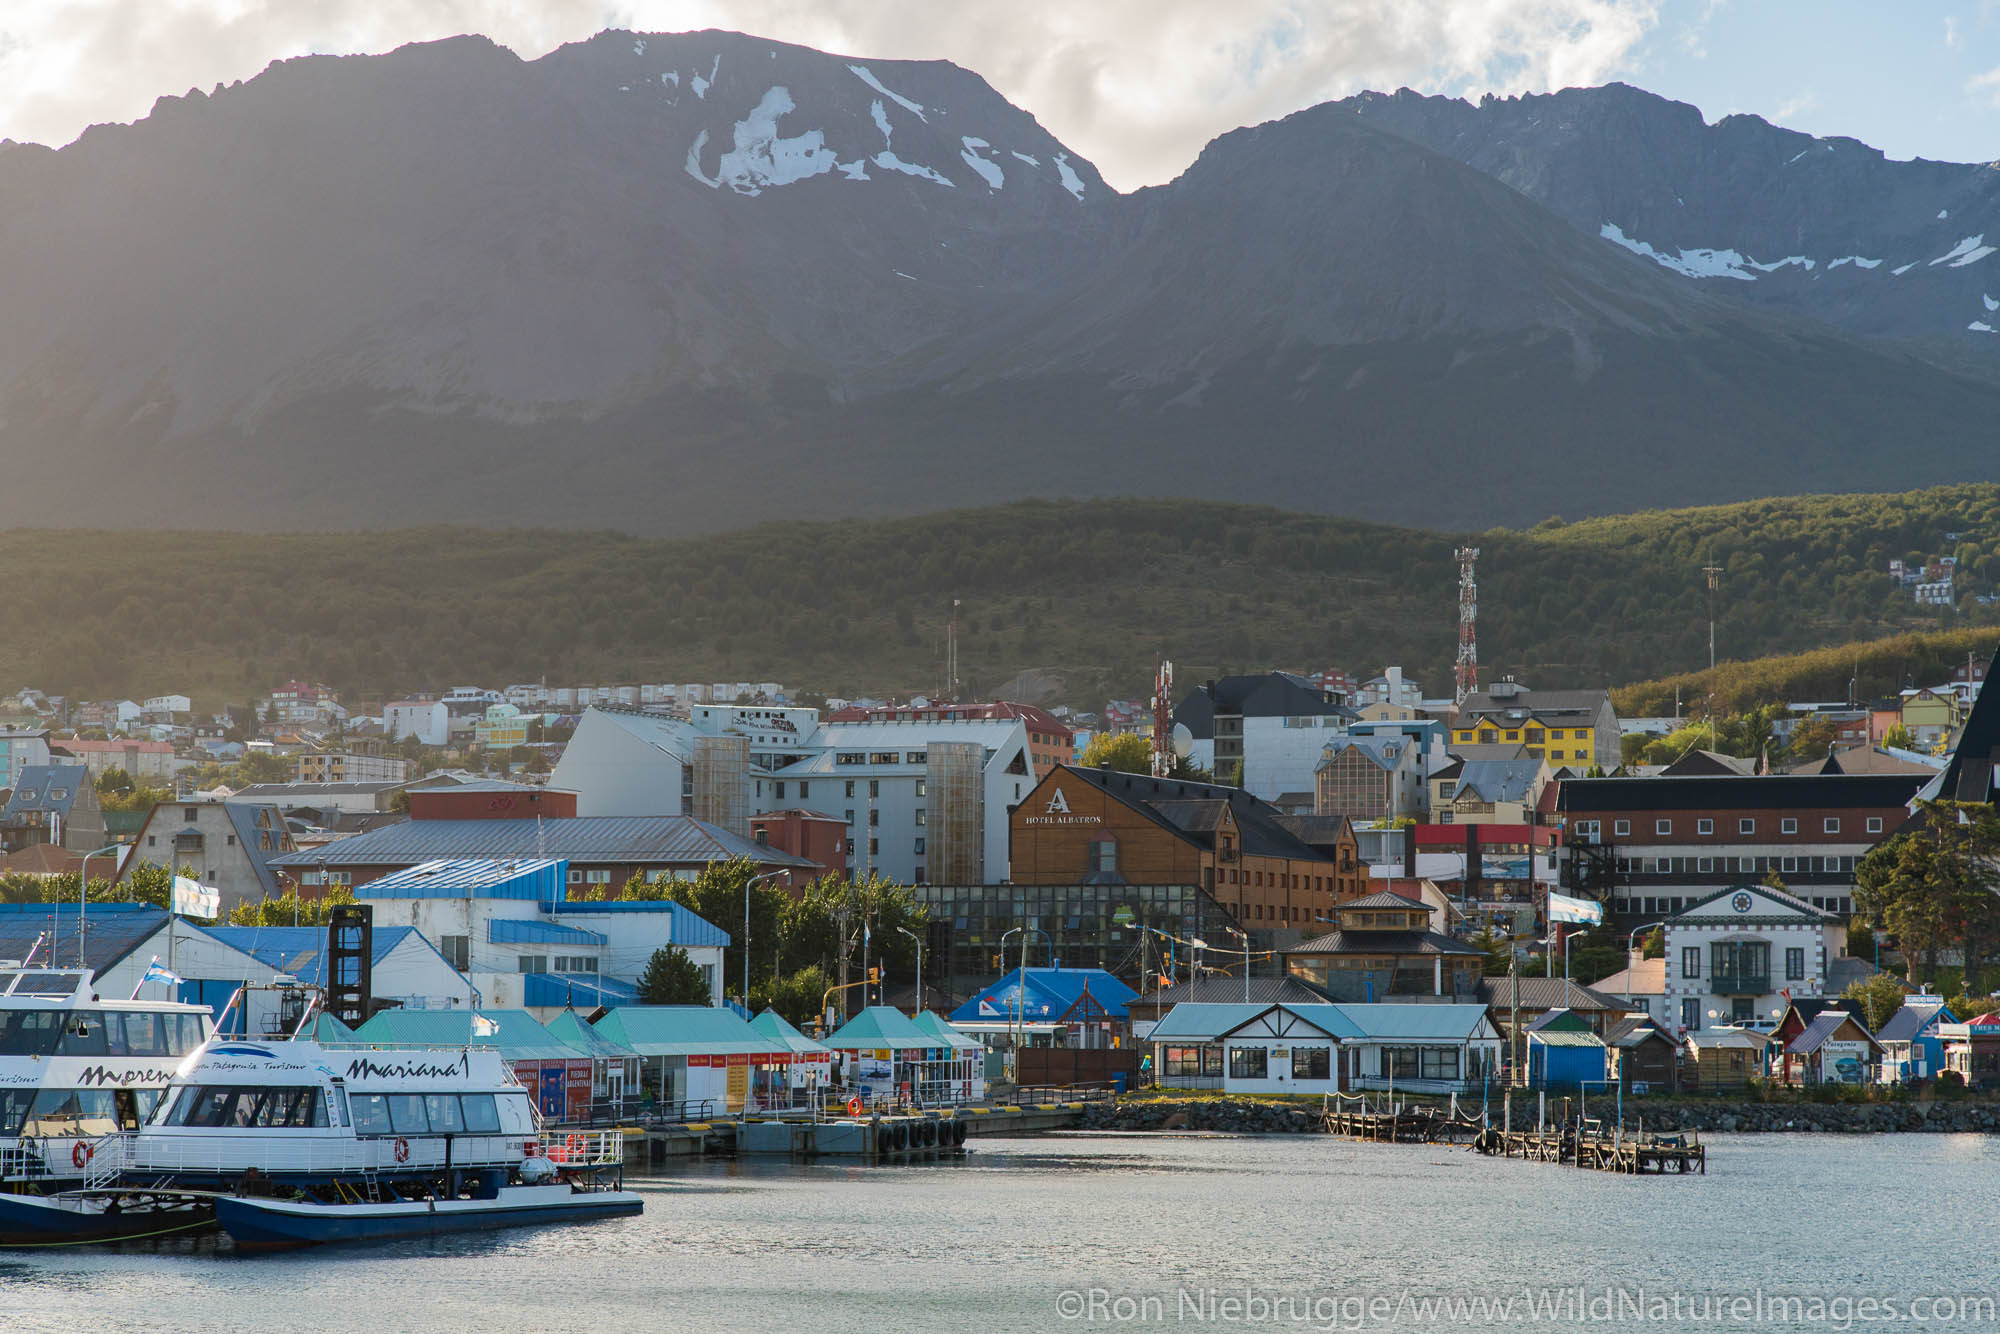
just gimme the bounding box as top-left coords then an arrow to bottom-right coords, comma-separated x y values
624,1102 -> 1084,1168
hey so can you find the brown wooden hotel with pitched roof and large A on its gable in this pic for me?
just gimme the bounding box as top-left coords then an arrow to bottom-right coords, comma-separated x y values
1008,764 -> 1366,944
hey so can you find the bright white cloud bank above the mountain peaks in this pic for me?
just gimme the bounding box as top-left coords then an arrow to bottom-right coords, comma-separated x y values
0,0 -> 1656,188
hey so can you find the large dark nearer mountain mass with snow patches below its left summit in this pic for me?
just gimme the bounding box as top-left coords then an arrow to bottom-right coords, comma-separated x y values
0,32 -> 2000,534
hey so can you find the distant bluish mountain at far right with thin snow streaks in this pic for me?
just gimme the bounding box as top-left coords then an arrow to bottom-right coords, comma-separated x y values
1336,84 -> 2000,354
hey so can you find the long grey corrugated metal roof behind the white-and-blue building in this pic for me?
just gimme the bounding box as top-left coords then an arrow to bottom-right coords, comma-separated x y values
272,816 -> 818,870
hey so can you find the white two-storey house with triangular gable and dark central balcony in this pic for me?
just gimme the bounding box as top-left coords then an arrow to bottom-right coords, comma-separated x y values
1662,884 -> 1848,1034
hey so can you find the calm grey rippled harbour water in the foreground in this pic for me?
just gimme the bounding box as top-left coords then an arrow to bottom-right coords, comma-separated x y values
0,1136 -> 2000,1334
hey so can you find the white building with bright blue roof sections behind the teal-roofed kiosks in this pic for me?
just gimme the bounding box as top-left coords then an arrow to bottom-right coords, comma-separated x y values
356,860 -> 730,1018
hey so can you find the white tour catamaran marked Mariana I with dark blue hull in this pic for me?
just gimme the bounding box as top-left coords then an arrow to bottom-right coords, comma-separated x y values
124,1012 -> 642,1250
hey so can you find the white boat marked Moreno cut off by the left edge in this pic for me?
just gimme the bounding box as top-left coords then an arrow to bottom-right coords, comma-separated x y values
0,966 -> 212,1246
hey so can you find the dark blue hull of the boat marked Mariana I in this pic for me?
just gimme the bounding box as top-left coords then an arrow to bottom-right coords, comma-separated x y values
216,1190 -> 644,1250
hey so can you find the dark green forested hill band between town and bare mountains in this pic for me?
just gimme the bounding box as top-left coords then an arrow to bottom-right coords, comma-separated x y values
15,486 -> 2000,706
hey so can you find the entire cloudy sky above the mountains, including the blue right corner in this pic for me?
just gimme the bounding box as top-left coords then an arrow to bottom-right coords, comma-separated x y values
0,0 -> 2000,190
